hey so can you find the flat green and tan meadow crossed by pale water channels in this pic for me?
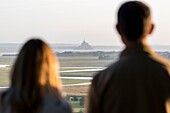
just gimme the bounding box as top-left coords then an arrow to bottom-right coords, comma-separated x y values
0,56 -> 113,113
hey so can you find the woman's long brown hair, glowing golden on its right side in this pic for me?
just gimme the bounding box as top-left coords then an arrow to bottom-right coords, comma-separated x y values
11,39 -> 61,98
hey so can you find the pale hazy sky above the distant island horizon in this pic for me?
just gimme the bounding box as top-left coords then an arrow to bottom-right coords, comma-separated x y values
0,0 -> 170,45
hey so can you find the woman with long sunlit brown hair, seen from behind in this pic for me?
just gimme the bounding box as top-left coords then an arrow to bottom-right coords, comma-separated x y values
0,39 -> 71,113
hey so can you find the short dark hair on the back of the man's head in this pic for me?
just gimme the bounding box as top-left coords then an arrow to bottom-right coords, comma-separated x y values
118,1 -> 150,41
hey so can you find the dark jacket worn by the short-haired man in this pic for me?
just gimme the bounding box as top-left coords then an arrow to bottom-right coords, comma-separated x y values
87,45 -> 170,113
